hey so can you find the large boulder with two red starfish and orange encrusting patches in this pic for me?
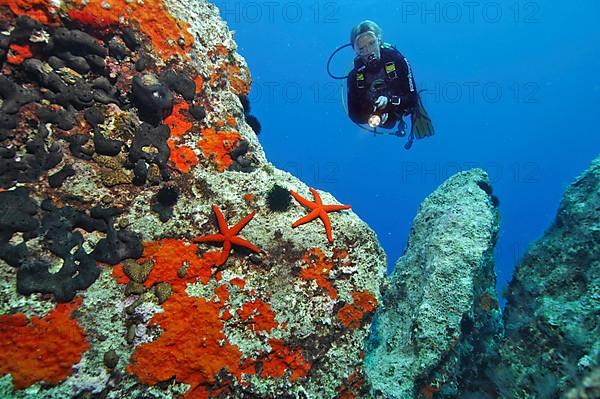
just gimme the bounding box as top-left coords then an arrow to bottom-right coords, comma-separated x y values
0,0 -> 386,398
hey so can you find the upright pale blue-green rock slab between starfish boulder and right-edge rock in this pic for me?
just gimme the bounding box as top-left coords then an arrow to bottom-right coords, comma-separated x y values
365,169 -> 502,399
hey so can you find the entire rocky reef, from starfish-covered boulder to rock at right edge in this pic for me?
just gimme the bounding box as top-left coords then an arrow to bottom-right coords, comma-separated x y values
0,0 -> 600,399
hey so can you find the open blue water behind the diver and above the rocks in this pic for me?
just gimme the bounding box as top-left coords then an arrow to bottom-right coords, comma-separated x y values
216,0 -> 600,300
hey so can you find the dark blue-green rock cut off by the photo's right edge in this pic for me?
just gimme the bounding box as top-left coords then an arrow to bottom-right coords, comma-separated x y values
488,158 -> 600,397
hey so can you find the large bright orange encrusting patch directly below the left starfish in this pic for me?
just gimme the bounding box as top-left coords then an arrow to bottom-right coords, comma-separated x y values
113,240 -> 311,398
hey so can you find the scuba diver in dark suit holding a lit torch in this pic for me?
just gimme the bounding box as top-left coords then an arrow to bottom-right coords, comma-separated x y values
327,20 -> 434,149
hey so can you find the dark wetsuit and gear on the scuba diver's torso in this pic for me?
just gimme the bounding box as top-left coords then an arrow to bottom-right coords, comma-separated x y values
347,46 -> 418,129
